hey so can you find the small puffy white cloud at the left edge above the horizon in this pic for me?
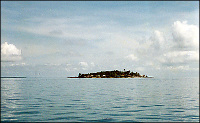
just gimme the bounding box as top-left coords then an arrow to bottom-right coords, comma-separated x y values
1,42 -> 21,62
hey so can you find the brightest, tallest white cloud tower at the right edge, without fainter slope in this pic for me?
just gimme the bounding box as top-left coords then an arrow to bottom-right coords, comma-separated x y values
163,21 -> 199,68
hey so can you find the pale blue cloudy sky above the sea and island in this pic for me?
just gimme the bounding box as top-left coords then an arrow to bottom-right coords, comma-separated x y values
1,1 -> 199,78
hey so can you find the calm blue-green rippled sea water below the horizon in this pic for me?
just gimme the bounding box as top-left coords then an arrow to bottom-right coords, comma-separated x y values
1,78 -> 199,122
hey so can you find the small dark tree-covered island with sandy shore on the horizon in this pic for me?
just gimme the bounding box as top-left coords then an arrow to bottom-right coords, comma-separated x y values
68,69 -> 153,78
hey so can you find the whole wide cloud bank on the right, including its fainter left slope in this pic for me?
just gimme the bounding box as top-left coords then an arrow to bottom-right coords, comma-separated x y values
133,21 -> 199,70
